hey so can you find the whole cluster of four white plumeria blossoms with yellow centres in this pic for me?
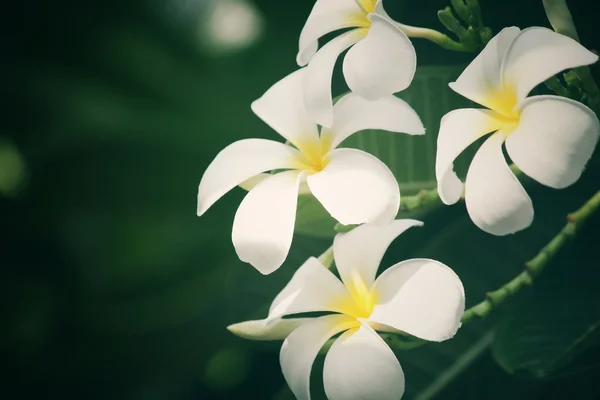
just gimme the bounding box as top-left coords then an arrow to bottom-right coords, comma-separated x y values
197,0 -> 600,400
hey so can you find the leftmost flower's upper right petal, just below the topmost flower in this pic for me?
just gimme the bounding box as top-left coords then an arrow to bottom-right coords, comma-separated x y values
331,93 -> 425,148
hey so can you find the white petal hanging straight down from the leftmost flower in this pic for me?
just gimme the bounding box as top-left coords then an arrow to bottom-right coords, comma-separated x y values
231,171 -> 304,274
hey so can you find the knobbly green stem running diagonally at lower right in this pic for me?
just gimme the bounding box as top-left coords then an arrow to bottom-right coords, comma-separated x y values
462,191 -> 600,323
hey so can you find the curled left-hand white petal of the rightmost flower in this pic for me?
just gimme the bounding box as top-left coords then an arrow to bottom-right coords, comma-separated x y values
435,108 -> 501,204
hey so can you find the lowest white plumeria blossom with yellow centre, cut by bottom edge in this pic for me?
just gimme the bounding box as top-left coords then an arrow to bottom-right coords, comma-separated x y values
228,219 -> 465,400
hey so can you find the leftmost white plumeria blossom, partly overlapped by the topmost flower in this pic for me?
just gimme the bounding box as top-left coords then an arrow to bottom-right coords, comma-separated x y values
198,70 -> 425,274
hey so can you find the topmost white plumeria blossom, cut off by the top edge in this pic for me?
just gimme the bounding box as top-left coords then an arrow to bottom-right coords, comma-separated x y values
296,0 -> 417,127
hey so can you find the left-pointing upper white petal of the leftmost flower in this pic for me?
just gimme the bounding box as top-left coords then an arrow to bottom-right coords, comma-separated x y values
197,139 -> 299,216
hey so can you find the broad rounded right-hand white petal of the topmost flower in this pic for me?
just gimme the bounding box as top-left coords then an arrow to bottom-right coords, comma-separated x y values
343,14 -> 417,100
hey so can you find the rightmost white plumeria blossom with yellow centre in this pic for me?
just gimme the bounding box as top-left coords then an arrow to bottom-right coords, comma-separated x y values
436,27 -> 600,235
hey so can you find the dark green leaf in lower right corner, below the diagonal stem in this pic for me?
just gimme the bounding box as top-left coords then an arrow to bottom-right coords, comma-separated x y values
492,225 -> 600,379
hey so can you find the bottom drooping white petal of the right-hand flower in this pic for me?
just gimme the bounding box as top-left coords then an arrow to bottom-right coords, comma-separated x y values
465,132 -> 533,236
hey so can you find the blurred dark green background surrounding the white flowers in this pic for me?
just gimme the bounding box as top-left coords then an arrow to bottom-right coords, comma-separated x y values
0,0 -> 600,400
